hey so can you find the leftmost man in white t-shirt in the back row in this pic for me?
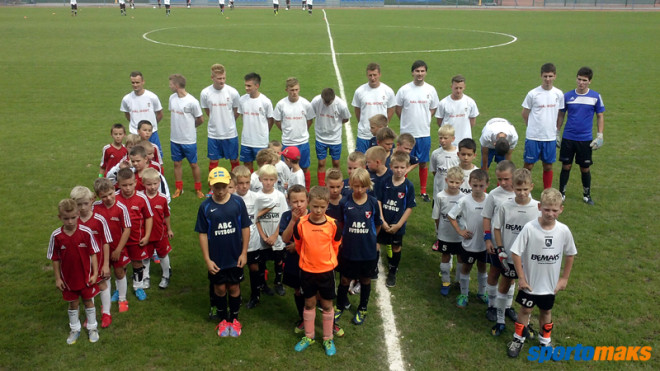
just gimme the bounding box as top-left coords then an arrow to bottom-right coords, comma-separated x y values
119,71 -> 163,156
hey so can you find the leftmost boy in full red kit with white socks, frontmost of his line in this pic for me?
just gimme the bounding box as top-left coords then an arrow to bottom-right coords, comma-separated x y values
47,199 -> 99,344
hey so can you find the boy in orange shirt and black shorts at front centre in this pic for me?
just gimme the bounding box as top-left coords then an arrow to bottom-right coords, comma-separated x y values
293,186 -> 342,356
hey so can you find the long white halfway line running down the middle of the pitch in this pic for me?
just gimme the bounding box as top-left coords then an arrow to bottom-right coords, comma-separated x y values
323,9 -> 405,371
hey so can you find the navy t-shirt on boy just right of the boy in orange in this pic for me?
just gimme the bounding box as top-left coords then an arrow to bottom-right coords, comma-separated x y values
339,195 -> 383,261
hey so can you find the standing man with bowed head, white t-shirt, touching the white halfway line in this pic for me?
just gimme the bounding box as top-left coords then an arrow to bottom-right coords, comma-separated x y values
312,88 -> 351,186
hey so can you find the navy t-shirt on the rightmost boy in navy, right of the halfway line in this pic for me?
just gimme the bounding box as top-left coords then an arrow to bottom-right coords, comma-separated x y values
376,178 -> 417,236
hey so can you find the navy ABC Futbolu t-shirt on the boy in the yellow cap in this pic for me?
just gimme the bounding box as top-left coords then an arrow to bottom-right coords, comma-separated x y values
195,195 -> 252,269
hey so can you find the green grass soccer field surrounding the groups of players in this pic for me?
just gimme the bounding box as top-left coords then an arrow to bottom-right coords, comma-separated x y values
0,4 -> 660,370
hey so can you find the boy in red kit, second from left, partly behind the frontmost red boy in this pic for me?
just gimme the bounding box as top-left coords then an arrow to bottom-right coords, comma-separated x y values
70,186 -> 112,328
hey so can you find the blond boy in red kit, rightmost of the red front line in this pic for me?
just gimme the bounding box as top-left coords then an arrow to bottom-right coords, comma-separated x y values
142,168 -> 174,289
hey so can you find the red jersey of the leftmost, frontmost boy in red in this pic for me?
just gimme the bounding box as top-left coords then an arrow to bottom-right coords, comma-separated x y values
47,225 -> 99,291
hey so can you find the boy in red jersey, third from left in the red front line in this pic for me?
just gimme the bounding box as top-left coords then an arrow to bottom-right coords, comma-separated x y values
94,178 -> 131,313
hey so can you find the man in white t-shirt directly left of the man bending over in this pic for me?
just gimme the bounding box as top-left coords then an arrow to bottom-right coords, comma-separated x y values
435,75 -> 479,146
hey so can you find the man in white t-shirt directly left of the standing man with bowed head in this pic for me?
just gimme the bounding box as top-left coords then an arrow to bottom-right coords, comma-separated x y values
273,77 -> 315,190
